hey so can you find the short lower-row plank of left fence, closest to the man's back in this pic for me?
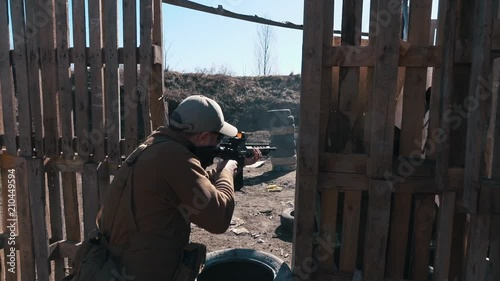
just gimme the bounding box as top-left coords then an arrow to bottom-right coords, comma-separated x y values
82,162 -> 99,235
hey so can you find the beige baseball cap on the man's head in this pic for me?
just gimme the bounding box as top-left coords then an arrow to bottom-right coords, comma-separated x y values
170,95 -> 238,137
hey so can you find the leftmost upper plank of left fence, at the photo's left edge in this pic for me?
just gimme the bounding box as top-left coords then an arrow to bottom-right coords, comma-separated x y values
0,2 -> 18,154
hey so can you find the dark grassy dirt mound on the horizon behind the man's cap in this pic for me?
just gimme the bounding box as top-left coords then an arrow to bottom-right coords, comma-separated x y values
165,72 -> 301,132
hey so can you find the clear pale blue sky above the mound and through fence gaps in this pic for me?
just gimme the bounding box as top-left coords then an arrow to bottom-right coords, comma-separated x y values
9,0 -> 438,75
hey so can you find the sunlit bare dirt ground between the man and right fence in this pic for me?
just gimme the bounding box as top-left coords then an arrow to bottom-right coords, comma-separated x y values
191,130 -> 295,266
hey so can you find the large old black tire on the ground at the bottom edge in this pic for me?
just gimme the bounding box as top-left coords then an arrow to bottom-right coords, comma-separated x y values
196,249 -> 292,281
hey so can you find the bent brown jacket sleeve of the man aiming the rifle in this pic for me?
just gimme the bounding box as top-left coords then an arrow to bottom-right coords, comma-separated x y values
163,150 -> 234,234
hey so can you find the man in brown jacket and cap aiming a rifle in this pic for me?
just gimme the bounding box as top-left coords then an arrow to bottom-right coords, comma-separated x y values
98,95 -> 261,281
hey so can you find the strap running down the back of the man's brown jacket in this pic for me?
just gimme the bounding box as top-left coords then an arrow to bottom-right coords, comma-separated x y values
100,135 -> 169,235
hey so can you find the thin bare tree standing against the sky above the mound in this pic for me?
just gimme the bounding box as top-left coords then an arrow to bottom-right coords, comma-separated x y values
255,25 -> 275,76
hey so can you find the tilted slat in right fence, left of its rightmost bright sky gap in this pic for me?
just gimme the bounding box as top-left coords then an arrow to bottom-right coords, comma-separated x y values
387,0 -> 432,279
